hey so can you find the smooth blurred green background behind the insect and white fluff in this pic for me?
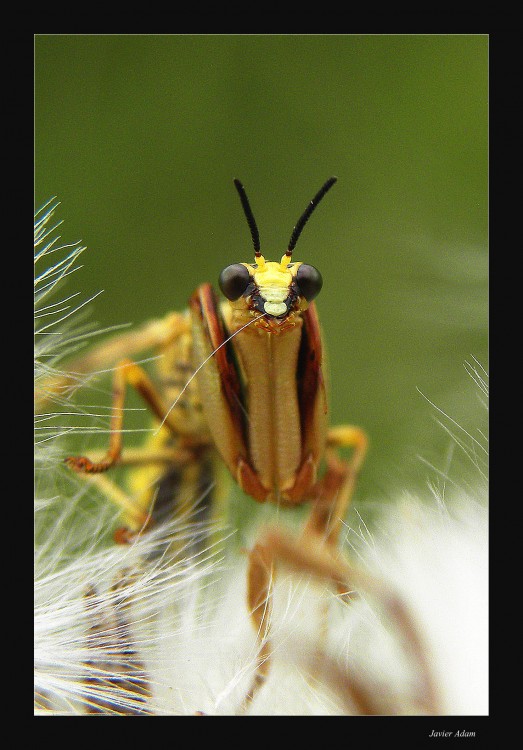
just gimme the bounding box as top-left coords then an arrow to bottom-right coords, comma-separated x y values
35,35 -> 488,524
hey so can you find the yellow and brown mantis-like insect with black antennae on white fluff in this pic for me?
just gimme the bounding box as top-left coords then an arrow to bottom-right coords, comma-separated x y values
60,177 -> 367,698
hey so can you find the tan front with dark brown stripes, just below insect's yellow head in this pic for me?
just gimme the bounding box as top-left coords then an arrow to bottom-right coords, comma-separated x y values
191,284 -> 327,504
